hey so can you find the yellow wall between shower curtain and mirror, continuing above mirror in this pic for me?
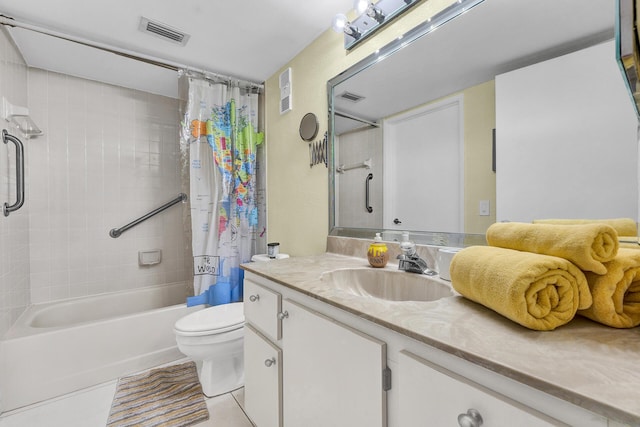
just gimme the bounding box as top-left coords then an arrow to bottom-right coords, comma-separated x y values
265,0 -> 454,256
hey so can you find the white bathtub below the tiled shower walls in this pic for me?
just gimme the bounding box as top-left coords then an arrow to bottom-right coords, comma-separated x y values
0,283 -> 203,411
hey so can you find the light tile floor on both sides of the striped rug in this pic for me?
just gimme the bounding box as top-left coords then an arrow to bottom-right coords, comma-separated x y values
0,362 -> 254,427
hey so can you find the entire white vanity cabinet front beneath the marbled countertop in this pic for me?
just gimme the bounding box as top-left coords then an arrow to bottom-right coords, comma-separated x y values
244,272 -> 623,427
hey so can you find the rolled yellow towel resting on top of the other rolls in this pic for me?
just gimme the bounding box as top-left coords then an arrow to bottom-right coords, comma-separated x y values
487,222 -> 619,274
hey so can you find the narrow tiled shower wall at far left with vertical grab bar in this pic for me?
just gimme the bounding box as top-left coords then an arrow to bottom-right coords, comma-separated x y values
0,28 -> 29,337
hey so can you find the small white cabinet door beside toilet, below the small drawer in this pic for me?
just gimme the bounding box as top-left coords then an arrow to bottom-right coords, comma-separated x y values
244,324 -> 282,427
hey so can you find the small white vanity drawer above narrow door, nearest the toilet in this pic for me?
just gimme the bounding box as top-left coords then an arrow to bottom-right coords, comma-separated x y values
244,279 -> 282,341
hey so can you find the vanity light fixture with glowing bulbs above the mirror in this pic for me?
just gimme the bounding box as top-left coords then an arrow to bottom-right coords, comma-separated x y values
331,0 -> 419,50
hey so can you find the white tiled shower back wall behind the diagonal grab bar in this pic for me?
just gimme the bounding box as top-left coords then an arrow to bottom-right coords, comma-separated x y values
27,68 -> 191,303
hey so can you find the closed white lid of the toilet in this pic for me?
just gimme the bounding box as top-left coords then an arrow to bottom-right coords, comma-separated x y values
174,302 -> 244,335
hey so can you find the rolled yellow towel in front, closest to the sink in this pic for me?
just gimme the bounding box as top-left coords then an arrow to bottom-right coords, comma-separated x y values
449,246 -> 591,331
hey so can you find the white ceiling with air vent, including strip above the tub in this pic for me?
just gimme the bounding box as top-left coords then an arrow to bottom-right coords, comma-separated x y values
0,0 -> 353,97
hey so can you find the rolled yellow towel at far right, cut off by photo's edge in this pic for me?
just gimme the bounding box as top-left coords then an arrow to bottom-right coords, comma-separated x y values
578,248 -> 640,328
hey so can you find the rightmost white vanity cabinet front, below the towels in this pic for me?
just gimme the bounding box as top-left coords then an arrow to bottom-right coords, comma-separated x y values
394,351 -> 567,427
